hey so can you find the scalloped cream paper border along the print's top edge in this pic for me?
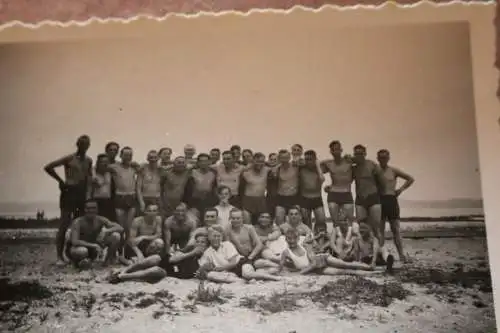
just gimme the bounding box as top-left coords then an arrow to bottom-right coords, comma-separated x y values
0,0 -> 496,32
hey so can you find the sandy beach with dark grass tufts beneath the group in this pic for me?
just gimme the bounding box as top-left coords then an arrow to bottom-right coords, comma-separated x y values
0,222 -> 496,333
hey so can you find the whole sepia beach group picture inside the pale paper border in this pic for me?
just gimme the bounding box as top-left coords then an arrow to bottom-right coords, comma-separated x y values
0,7 -> 496,333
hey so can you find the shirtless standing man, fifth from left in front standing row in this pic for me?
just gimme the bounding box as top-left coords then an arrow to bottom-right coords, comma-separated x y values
160,156 -> 191,218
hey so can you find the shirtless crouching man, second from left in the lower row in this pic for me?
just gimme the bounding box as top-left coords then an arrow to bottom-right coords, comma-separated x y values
125,205 -> 164,260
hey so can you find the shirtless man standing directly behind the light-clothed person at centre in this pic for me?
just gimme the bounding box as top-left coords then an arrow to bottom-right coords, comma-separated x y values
216,151 -> 243,208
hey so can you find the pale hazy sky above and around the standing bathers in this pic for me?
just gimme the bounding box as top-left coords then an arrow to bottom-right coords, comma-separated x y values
0,20 -> 481,202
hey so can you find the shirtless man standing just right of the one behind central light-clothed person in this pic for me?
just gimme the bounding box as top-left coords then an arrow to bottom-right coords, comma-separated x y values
239,153 -> 270,224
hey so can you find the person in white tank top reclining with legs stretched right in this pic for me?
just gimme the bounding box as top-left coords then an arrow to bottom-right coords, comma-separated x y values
280,228 -> 382,275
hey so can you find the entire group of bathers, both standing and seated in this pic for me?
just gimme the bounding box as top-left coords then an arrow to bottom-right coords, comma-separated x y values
45,135 -> 414,283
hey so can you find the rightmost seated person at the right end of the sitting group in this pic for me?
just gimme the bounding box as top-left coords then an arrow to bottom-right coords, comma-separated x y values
352,223 -> 394,273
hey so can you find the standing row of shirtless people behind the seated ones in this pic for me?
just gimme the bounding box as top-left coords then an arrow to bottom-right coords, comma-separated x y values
45,136 -> 413,260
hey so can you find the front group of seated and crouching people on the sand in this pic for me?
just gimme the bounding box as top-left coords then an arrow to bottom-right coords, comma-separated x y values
66,200 -> 394,283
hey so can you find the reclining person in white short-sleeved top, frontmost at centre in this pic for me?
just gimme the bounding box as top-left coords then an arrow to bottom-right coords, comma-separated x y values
197,225 -> 280,283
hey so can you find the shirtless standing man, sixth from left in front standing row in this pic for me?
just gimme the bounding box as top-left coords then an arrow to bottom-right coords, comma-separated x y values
185,154 -> 217,220
